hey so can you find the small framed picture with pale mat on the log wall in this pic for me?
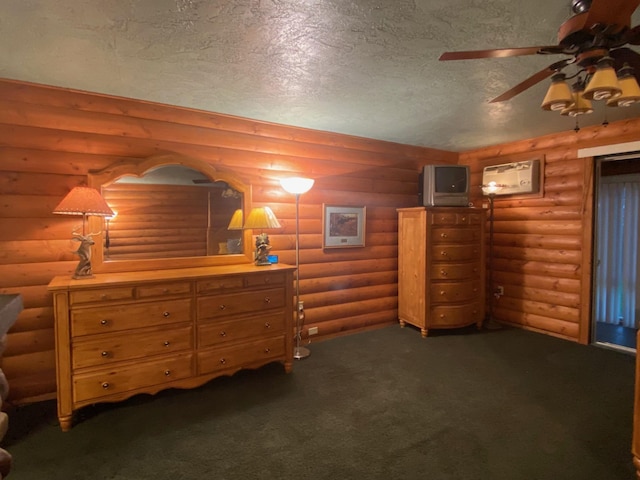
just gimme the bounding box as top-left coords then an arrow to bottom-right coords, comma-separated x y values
322,204 -> 367,248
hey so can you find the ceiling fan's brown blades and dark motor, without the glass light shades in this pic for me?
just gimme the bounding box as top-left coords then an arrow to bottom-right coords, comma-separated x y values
440,0 -> 640,103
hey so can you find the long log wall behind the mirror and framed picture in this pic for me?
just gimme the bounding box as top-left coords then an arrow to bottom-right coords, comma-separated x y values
0,80 -> 458,404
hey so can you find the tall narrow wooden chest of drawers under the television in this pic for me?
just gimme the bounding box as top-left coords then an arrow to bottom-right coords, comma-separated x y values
398,207 -> 485,337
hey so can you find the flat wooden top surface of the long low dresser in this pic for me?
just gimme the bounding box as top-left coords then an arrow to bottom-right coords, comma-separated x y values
47,263 -> 296,290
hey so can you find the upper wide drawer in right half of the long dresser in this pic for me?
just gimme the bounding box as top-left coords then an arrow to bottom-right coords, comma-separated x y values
198,288 -> 285,319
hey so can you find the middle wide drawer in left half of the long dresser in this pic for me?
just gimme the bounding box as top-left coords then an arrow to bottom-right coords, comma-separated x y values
71,325 -> 193,370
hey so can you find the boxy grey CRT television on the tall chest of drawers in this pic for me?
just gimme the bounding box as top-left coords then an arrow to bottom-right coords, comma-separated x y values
418,165 -> 470,207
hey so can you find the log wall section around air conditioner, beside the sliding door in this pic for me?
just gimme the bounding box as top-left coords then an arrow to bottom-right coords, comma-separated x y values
460,119 -> 640,343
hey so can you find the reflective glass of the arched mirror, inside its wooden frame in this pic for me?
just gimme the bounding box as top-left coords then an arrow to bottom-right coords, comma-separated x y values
102,165 -> 243,261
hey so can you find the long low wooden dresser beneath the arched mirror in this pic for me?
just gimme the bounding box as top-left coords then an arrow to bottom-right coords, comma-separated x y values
49,264 -> 295,431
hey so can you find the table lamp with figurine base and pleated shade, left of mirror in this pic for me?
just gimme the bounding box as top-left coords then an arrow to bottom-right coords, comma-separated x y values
53,187 -> 115,279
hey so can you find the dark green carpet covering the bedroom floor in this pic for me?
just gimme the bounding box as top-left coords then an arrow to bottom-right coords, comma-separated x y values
4,326 -> 634,480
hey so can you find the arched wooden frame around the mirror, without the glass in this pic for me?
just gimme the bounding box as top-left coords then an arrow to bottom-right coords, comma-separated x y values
88,153 -> 253,273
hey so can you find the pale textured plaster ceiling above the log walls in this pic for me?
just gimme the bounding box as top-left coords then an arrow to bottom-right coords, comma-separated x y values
0,0 -> 640,151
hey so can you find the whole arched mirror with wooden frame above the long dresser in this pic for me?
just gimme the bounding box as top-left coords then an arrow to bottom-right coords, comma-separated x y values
89,154 -> 252,272
